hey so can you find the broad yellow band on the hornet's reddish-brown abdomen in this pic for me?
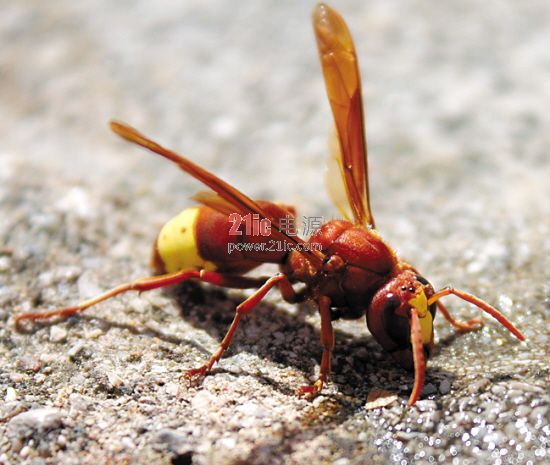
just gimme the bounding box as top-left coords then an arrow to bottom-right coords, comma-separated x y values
157,207 -> 216,273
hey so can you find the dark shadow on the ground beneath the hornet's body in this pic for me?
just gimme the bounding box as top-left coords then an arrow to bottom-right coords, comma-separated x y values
168,282 -> 460,405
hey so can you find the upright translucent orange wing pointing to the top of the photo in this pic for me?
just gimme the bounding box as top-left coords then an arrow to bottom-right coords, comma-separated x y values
313,4 -> 374,228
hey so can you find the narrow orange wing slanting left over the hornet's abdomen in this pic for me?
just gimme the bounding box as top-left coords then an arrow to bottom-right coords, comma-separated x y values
110,121 -> 324,266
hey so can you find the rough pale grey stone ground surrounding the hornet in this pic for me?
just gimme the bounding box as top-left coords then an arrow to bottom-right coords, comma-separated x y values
0,0 -> 550,465
